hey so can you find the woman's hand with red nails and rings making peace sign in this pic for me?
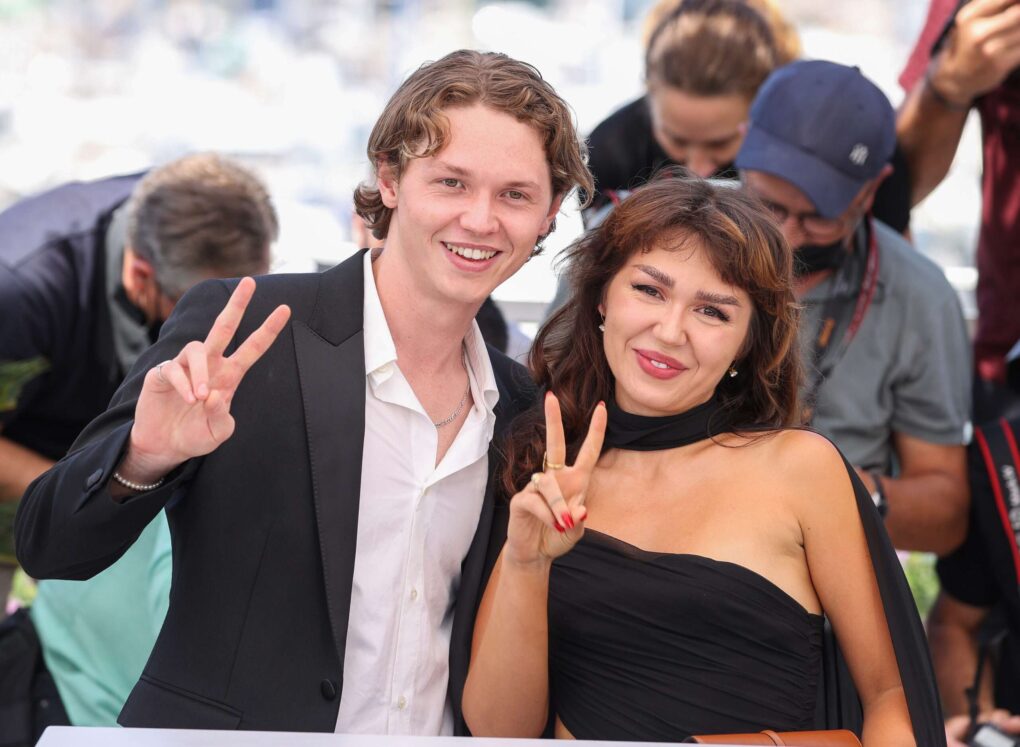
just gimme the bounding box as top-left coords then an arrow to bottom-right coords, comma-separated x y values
506,392 -> 606,564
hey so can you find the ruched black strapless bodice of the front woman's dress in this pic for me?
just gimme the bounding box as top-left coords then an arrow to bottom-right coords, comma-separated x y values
549,530 -> 823,742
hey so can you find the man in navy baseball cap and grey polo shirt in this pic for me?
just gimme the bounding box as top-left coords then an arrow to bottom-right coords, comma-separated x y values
736,60 -> 970,553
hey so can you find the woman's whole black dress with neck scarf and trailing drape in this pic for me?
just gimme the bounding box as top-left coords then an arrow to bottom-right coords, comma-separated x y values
534,399 -> 946,747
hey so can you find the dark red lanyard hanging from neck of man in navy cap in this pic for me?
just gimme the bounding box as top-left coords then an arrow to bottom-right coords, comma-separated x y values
804,215 -> 879,424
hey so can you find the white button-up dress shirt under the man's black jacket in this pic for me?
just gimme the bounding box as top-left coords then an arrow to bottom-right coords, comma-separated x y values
337,252 -> 499,736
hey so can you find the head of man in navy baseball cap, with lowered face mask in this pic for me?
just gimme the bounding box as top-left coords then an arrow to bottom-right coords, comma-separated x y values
735,60 -> 896,279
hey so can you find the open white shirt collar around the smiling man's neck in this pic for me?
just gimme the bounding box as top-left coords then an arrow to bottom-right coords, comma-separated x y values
363,251 -> 500,418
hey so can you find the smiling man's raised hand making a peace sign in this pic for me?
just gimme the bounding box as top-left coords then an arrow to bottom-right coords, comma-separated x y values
119,278 -> 291,483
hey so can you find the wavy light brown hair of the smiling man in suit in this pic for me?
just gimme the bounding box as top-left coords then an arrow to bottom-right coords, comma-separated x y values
354,49 -> 594,239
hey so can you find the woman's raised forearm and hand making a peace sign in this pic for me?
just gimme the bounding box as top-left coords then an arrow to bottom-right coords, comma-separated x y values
462,394 -> 606,737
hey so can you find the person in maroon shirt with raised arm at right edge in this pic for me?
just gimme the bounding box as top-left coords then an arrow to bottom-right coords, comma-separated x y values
898,0 -> 1020,422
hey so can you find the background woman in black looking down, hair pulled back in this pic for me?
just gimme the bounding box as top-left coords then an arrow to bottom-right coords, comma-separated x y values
584,0 -> 910,233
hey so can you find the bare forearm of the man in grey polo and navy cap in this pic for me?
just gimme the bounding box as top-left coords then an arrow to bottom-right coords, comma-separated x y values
858,433 -> 970,555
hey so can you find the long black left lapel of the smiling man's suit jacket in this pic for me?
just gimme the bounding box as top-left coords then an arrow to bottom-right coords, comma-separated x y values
294,252 -> 365,669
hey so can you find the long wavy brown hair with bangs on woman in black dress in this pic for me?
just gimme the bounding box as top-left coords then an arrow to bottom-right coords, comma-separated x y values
503,167 -> 801,495
